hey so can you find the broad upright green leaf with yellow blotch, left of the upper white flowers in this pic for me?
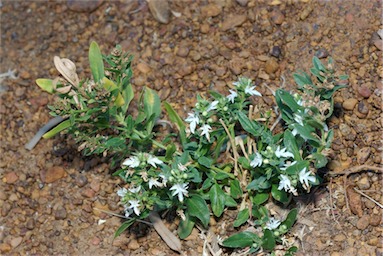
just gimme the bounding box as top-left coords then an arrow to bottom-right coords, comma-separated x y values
144,87 -> 161,133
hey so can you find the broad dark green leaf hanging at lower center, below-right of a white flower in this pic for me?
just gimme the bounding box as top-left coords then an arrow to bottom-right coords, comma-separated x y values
186,194 -> 210,227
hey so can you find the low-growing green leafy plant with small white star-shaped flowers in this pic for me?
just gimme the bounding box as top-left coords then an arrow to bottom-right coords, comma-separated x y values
37,42 -> 347,255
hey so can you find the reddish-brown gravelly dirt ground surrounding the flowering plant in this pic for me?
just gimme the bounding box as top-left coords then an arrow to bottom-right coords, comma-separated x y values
0,0 -> 383,256
